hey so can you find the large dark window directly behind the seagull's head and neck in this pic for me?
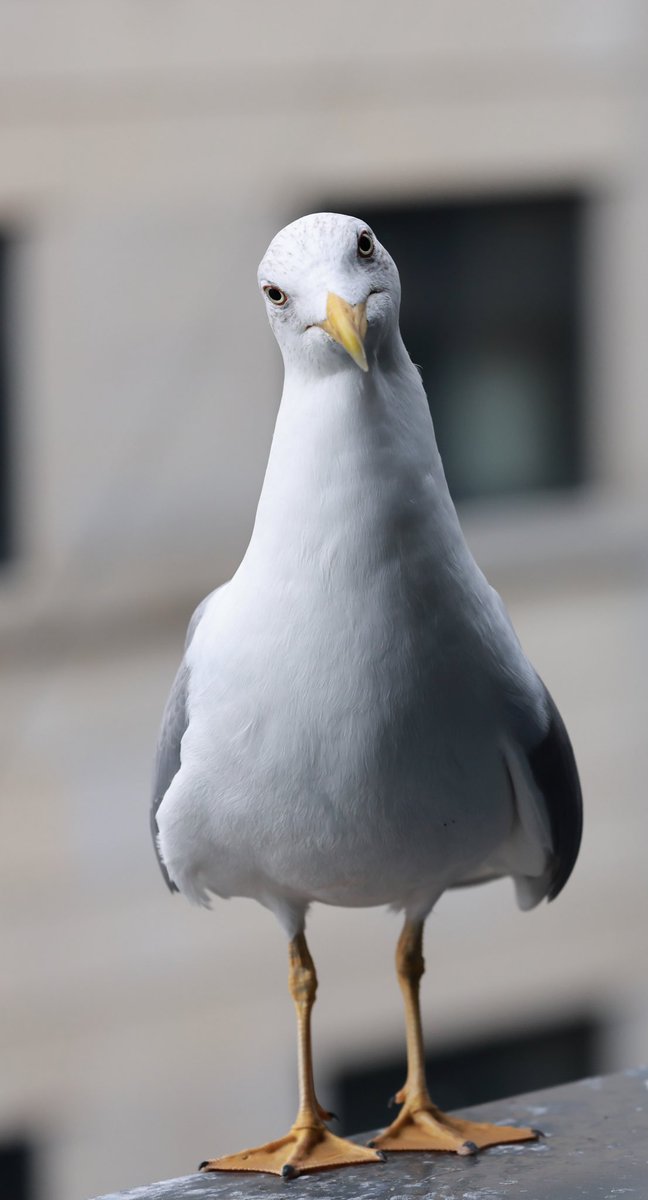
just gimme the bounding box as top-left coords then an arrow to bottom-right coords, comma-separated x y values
321,194 -> 587,500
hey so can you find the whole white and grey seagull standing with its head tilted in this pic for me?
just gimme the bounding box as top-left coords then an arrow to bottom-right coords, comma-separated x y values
151,212 -> 582,1178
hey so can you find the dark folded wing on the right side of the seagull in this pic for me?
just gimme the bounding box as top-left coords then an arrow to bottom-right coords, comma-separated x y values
528,689 -> 583,900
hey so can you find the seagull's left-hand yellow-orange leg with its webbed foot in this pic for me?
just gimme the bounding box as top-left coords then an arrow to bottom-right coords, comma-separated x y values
200,934 -> 384,1178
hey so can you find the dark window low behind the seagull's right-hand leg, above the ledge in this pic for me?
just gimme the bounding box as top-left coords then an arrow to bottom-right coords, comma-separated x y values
332,1018 -> 601,1133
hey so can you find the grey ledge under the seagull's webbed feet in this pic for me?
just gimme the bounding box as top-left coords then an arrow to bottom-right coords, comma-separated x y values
96,1067 -> 648,1200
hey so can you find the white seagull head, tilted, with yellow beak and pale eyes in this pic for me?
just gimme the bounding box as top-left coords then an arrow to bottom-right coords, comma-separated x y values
258,212 -> 401,374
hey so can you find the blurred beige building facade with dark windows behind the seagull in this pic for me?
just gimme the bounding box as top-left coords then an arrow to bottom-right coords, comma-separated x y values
0,0 -> 648,1200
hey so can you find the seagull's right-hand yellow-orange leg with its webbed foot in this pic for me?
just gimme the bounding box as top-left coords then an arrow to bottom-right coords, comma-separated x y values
372,920 -> 538,1154
